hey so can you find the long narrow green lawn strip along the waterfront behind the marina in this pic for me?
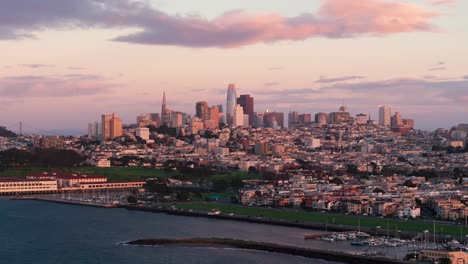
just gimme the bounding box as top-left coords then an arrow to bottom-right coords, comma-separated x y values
176,203 -> 468,238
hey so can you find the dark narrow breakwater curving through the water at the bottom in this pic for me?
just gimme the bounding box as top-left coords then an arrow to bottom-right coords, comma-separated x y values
123,238 -> 417,264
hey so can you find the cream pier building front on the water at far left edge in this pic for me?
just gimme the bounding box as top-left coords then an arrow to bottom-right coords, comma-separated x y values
0,178 -> 57,195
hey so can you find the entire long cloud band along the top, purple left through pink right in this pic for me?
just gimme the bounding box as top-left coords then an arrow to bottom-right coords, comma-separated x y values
0,0 -> 438,48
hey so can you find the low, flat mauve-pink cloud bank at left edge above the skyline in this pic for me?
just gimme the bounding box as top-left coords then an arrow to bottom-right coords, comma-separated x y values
0,75 -> 116,98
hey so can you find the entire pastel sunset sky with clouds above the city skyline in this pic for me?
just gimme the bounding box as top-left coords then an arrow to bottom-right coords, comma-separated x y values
0,0 -> 468,134
